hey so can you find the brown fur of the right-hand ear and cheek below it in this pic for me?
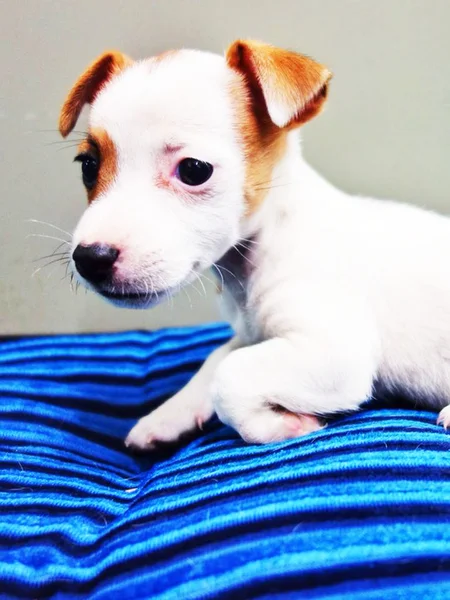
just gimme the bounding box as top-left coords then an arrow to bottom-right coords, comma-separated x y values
226,41 -> 331,213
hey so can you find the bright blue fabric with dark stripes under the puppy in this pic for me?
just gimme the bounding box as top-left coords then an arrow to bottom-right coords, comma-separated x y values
0,325 -> 450,600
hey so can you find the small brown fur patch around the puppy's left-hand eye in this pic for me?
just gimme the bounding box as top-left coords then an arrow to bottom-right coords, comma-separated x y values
78,128 -> 117,203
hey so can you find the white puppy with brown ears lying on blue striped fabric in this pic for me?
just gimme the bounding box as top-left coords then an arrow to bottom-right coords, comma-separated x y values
60,41 -> 450,449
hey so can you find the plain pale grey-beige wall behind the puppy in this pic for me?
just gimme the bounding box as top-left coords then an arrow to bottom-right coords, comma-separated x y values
0,0 -> 450,334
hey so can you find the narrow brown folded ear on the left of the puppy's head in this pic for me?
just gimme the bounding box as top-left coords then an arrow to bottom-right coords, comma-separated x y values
59,51 -> 132,137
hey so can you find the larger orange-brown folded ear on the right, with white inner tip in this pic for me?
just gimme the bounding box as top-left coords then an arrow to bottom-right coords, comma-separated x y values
226,40 -> 331,128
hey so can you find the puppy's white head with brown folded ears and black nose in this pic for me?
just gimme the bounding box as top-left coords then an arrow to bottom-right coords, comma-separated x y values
59,41 -> 330,307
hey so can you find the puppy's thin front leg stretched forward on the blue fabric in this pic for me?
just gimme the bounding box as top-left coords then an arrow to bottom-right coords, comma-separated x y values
125,338 -> 238,450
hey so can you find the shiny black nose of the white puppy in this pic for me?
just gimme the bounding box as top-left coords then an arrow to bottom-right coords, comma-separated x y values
72,244 -> 119,283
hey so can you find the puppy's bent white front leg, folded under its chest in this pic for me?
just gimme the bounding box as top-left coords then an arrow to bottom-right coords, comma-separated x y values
213,337 -> 375,443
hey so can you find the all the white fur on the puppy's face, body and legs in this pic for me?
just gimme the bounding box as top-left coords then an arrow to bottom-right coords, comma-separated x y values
68,51 -> 450,448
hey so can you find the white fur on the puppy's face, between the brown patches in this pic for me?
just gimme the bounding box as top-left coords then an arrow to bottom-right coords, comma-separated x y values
73,50 -> 245,306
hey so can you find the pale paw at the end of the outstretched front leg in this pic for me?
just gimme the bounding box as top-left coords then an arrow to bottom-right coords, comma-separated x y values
125,396 -> 212,450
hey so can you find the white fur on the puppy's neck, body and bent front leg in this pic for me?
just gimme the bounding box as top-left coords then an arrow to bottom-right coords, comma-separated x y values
214,134 -> 450,442
